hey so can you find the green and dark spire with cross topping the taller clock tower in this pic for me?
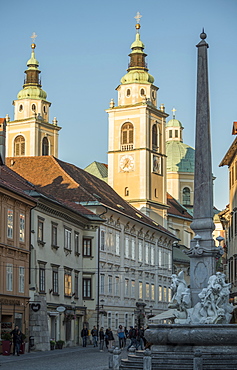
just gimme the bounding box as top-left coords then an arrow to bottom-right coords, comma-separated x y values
121,12 -> 154,84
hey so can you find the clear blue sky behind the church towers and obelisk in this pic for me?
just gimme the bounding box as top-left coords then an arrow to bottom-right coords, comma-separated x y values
0,0 -> 237,210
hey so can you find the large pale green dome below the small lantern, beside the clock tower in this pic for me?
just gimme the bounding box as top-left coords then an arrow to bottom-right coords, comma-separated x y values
166,140 -> 195,173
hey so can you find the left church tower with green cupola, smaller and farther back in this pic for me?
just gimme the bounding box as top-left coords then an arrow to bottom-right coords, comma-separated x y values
6,34 -> 61,157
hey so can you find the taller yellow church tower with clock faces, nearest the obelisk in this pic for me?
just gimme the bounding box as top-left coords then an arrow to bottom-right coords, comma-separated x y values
107,13 -> 168,226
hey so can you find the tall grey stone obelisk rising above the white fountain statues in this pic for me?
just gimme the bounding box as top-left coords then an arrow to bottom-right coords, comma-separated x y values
188,30 -> 219,306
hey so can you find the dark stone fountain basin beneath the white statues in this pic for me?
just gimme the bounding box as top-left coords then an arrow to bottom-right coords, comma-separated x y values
145,324 -> 237,346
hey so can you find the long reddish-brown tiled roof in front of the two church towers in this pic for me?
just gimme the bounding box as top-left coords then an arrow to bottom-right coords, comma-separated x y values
6,156 -> 175,238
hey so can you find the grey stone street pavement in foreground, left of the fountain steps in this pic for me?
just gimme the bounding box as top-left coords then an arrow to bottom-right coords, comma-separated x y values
0,346 -> 115,370
